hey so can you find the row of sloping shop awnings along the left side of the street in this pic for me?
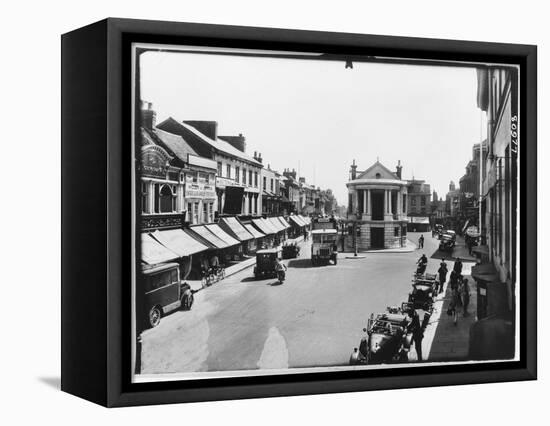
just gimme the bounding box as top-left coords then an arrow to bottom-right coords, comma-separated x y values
141,215 -> 310,279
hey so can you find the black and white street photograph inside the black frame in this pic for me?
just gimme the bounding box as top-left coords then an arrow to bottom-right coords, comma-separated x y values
129,44 -> 521,382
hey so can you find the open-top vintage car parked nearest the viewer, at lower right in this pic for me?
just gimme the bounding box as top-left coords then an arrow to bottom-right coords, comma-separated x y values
349,310 -> 412,365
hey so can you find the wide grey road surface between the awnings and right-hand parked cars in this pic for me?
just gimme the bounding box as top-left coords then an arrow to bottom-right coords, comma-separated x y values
142,233 -> 458,373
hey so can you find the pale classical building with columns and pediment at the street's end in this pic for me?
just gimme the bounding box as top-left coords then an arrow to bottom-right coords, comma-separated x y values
346,160 -> 408,251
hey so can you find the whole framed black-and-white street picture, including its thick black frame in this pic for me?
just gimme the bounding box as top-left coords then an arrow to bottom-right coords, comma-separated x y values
62,19 -> 537,406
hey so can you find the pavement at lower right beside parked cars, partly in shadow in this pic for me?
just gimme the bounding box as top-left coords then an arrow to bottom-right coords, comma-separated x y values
422,263 -> 477,362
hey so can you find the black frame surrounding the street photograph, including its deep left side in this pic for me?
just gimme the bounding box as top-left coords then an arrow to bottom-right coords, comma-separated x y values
61,18 -> 537,407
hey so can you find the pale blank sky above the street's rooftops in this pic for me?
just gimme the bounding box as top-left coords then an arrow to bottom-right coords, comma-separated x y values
141,48 -> 485,204
